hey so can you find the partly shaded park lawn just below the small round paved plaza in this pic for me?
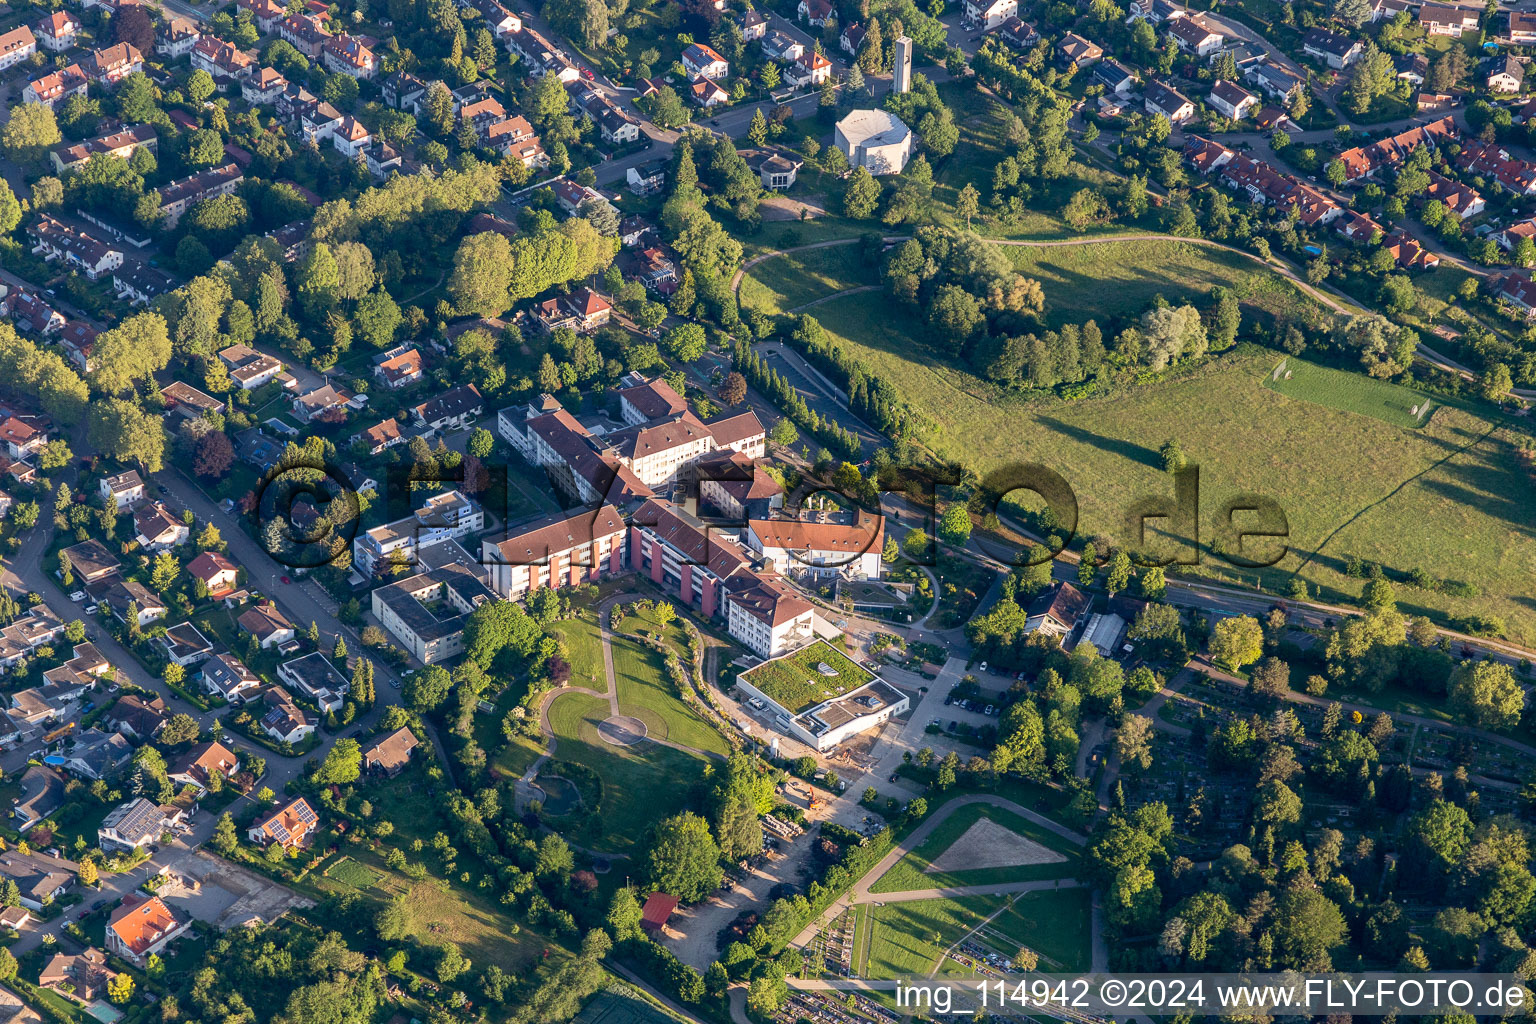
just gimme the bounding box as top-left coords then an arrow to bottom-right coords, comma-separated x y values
548,694 -> 700,852
